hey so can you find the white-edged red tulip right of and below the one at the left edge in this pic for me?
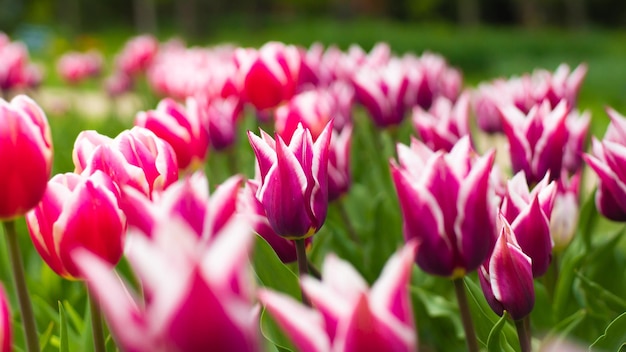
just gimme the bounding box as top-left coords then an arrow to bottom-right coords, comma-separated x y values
26,171 -> 126,279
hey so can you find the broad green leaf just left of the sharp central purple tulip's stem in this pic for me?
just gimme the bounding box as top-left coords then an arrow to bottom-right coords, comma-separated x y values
252,236 -> 301,300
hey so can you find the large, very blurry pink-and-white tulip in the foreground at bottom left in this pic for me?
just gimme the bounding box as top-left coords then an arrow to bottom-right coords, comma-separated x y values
74,219 -> 261,352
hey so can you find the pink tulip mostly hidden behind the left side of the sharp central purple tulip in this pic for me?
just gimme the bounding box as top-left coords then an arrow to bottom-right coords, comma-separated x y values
237,180 -> 313,263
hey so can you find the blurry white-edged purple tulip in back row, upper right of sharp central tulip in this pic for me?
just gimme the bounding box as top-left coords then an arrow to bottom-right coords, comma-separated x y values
353,60 -> 409,127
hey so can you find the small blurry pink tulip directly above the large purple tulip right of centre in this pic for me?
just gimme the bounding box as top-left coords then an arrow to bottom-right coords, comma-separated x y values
413,94 -> 470,152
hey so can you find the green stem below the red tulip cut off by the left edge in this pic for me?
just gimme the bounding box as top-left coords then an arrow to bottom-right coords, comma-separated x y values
3,220 -> 39,352
